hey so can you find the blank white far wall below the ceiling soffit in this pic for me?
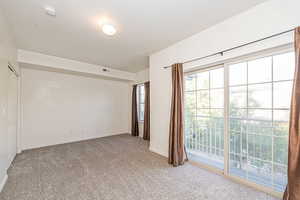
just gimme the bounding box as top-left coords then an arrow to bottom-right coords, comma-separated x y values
21,67 -> 130,149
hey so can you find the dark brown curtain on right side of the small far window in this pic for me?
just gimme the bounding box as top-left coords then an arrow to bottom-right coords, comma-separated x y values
143,82 -> 150,140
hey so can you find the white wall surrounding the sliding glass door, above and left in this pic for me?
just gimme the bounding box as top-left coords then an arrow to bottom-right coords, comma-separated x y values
150,0 -> 300,156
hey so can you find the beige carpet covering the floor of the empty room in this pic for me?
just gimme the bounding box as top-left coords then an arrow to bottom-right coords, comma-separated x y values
0,135 -> 273,200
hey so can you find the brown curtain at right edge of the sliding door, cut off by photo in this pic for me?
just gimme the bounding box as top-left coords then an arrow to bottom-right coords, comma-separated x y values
283,27 -> 300,200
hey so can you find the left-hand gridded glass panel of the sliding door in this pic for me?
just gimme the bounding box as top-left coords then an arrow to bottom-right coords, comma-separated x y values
185,67 -> 224,169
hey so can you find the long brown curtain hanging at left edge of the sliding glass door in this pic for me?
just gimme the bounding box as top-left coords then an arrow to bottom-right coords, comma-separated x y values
169,63 -> 186,167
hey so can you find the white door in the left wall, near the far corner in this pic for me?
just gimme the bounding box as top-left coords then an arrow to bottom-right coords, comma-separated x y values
7,69 -> 18,162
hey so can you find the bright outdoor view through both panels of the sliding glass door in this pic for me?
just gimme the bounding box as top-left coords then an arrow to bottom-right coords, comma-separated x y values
185,52 -> 295,192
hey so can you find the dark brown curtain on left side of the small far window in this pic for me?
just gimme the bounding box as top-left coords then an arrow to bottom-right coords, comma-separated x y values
131,85 -> 139,136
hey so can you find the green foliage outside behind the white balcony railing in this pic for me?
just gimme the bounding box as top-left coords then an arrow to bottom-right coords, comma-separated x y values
185,82 -> 288,171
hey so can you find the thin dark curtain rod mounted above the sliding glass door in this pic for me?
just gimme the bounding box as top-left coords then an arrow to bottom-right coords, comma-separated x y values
163,29 -> 295,69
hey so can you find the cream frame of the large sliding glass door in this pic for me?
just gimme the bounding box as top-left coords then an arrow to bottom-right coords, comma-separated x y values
184,45 -> 295,198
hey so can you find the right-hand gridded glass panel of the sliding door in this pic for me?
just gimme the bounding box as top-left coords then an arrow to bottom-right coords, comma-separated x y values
229,53 -> 295,191
